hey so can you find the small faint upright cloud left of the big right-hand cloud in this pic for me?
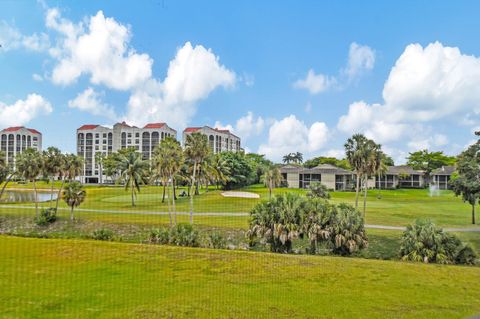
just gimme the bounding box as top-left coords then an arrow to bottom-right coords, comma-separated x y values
344,42 -> 375,81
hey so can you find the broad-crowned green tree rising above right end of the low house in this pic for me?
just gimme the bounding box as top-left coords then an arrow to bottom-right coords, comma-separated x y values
407,149 -> 456,182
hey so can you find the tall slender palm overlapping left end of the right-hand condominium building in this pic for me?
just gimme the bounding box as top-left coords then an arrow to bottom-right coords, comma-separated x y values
185,133 -> 210,224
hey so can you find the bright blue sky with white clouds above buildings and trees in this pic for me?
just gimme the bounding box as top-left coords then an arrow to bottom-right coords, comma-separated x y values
0,0 -> 480,163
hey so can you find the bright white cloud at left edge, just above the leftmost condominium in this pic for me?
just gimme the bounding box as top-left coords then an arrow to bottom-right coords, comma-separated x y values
0,93 -> 53,126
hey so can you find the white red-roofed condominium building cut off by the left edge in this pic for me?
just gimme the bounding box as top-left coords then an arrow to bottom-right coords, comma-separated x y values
0,126 -> 42,168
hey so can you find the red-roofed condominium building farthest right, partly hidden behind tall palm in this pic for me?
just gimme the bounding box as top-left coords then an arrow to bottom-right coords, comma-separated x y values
183,126 -> 242,154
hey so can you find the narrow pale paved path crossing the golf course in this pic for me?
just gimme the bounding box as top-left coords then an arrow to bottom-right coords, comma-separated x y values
0,205 -> 480,233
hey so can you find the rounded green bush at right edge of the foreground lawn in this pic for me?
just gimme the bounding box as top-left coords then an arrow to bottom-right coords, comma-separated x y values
400,220 -> 477,264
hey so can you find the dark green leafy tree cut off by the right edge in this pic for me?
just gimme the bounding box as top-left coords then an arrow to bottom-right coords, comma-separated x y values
452,141 -> 480,224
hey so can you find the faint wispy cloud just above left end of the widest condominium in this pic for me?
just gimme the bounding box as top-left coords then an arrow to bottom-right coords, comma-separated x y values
68,87 -> 118,121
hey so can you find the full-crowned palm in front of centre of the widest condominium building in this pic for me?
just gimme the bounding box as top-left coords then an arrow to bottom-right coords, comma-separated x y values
118,152 -> 148,207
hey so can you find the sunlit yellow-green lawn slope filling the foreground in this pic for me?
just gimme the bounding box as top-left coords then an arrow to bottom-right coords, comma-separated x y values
0,237 -> 480,318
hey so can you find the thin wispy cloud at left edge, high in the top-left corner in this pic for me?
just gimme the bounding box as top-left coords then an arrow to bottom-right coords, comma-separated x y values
0,21 -> 50,52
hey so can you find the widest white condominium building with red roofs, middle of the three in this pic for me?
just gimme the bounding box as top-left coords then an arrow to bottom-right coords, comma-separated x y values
77,122 -> 177,183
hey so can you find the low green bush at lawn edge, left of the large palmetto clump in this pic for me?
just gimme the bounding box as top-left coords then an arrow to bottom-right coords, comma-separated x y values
149,224 -> 200,247
